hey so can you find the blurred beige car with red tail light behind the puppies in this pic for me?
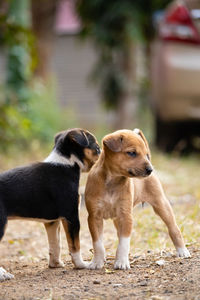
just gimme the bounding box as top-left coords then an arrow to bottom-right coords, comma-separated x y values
151,1 -> 200,152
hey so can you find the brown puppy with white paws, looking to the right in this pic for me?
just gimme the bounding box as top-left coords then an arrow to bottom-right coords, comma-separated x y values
85,129 -> 190,269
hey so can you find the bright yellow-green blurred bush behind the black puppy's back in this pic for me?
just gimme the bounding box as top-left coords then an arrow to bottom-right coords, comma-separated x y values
0,81 -> 77,152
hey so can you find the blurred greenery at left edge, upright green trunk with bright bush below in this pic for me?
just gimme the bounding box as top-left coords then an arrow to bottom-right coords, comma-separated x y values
0,0 -> 67,151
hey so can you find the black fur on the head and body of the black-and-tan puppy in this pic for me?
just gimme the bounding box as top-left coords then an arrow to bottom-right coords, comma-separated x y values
0,129 -> 99,247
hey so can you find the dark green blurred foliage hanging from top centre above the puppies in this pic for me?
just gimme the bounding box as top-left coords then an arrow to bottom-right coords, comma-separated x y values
77,0 -> 141,109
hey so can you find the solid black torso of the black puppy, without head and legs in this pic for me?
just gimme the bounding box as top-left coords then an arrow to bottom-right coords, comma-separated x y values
0,162 -> 80,220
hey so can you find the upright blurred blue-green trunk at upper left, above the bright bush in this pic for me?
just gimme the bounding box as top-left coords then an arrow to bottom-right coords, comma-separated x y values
4,0 -> 33,107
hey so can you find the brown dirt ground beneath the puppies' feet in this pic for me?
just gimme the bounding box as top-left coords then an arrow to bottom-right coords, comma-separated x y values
0,208 -> 200,300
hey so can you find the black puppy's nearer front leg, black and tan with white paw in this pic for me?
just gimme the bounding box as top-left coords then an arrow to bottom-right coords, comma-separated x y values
62,216 -> 86,269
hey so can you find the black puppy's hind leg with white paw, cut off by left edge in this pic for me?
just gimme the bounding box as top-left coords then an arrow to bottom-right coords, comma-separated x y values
0,204 -> 14,282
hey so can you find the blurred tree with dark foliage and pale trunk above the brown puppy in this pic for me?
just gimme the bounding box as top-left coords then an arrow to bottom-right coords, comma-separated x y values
77,0 -> 169,127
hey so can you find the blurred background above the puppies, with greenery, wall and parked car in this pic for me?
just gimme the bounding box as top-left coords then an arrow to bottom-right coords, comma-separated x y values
0,0 -> 200,153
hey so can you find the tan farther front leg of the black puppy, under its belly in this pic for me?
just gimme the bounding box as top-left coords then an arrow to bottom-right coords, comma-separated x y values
44,220 -> 64,268
